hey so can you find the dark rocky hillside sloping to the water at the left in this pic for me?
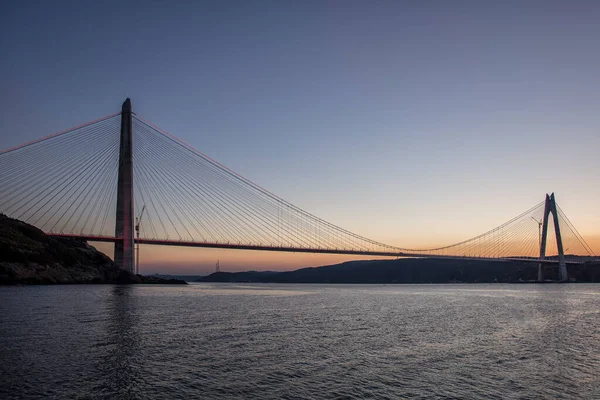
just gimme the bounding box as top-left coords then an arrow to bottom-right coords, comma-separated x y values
0,214 -> 185,285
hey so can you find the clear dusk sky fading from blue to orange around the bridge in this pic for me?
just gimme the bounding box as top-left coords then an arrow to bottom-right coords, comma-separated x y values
0,0 -> 600,273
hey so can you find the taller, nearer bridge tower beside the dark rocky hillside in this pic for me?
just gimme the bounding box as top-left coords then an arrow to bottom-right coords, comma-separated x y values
114,99 -> 135,273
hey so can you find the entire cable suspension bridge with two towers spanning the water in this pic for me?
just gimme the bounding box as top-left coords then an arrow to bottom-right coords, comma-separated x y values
0,99 -> 595,280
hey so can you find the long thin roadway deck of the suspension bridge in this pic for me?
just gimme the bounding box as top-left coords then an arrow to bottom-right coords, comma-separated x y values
47,233 -> 583,264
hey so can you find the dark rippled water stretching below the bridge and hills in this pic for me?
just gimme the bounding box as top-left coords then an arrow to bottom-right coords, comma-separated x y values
0,284 -> 600,399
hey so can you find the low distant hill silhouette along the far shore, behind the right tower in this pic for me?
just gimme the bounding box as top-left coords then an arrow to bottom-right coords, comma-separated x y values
197,258 -> 600,283
